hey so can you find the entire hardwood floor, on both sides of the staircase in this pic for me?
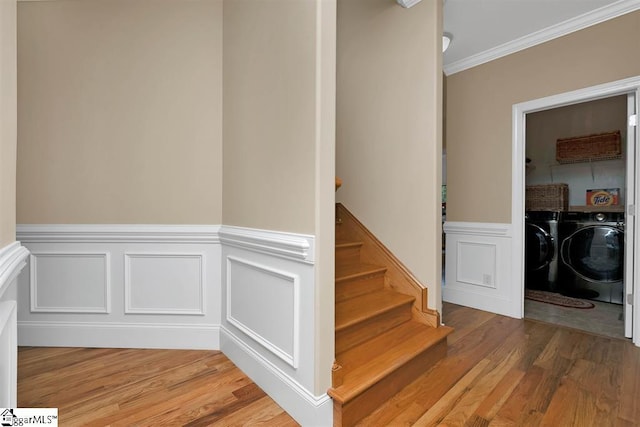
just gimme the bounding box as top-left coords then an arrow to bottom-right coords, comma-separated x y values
18,303 -> 640,427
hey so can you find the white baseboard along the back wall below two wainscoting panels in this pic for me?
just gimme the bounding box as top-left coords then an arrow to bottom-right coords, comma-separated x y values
18,321 -> 220,350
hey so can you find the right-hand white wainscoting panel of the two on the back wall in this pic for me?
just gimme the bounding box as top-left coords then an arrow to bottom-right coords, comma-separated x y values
124,253 -> 206,315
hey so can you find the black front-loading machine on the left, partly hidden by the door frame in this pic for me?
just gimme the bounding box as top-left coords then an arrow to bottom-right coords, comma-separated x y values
524,211 -> 563,292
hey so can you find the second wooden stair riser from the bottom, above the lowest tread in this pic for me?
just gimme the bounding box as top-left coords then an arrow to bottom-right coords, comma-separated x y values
335,303 -> 411,356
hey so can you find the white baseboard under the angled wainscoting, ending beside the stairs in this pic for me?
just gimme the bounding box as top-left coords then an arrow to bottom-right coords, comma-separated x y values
220,329 -> 333,427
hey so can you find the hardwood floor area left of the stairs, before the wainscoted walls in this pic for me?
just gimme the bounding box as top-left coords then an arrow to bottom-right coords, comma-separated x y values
18,347 -> 298,427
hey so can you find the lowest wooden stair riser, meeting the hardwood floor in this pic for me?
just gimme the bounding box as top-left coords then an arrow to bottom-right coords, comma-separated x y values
333,338 -> 447,427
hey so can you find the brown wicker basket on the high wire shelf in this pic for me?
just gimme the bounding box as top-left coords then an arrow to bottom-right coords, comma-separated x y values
556,130 -> 622,163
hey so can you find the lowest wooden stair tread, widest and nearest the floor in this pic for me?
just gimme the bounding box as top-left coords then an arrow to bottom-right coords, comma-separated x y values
329,321 -> 453,404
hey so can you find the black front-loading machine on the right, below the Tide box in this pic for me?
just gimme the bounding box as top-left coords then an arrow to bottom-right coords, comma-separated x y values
558,212 -> 624,304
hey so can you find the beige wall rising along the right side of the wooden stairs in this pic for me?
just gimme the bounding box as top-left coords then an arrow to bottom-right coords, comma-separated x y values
336,0 -> 442,308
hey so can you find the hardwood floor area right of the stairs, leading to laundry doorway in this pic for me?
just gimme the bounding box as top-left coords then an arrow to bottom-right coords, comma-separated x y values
359,303 -> 640,427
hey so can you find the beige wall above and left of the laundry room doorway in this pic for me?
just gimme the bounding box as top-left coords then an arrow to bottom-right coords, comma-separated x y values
446,12 -> 640,223
